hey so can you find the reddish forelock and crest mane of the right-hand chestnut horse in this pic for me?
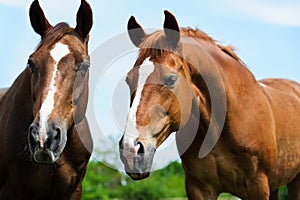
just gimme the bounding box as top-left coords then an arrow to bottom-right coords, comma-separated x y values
136,27 -> 245,65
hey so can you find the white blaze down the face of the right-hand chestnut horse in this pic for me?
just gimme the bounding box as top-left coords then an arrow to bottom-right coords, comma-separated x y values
123,59 -> 154,149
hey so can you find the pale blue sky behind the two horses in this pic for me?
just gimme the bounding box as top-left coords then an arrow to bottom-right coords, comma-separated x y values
0,0 -> 300,169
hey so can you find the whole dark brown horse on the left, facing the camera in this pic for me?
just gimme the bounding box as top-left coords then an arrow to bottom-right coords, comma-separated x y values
0,0 -> 92,200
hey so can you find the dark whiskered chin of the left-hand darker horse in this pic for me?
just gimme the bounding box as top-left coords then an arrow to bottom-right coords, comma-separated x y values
32,149 -> 59,165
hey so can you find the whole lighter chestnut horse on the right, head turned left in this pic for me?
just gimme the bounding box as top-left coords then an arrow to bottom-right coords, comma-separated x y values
120,11 -> 300,200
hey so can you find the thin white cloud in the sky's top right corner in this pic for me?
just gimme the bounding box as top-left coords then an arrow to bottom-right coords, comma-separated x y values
228,0 -> 300,26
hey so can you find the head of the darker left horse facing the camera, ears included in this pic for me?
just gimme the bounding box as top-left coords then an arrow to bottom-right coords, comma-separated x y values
27,0 -> 93,164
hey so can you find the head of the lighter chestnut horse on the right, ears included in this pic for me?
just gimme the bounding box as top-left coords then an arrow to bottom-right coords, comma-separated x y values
119,11 -> 198,179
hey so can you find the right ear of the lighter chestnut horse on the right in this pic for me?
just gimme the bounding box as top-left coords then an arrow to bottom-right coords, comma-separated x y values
164,10 -> 180,49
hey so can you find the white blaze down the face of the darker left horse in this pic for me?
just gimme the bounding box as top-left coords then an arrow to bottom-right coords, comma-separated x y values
38,42 -> 70,148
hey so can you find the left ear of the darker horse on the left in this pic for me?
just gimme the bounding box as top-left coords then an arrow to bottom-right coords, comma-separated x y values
29,0 -> 52,38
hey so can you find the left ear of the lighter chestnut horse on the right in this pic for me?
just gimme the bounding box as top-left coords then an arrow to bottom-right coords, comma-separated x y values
127,16 -> 146,47
